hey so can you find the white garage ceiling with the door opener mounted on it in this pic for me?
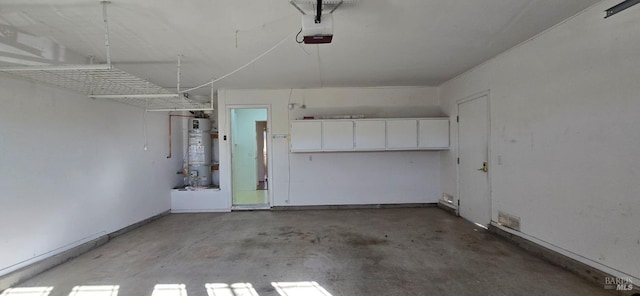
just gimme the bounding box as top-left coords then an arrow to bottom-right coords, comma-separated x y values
0,0 -> 604,93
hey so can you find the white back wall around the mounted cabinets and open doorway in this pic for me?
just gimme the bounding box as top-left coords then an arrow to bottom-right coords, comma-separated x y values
218,87 -> 443,206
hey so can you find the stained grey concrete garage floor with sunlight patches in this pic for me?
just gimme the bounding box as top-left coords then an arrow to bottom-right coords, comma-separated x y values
8,208 -> 611,296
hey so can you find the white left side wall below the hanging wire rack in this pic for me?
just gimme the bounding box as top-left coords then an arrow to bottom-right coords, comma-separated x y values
0,76 -> 182,275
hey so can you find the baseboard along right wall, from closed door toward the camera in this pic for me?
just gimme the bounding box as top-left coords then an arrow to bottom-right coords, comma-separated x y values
489,224 -> 640,296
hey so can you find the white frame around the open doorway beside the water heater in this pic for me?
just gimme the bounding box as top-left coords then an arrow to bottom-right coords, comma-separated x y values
225,104 -> 273,210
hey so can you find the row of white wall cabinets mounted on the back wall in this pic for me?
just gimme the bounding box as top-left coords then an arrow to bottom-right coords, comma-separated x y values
290,118 -> 449,152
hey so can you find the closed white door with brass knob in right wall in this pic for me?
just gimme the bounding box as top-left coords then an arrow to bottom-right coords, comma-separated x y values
458,95 -> 491,226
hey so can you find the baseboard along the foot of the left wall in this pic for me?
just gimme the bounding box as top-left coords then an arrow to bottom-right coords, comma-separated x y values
0,211 -> 169,291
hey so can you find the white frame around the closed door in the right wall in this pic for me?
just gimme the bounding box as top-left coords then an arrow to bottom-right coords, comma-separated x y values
456,90 -> 493,224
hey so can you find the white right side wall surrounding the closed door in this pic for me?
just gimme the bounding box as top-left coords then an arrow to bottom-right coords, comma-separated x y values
440,0 -> 640,279
